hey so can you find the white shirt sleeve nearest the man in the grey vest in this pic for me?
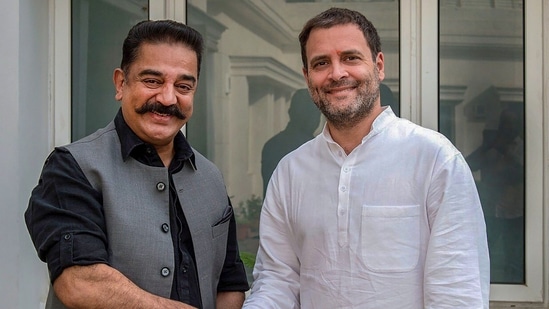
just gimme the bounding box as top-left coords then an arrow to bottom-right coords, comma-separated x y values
243,171 -> 300,309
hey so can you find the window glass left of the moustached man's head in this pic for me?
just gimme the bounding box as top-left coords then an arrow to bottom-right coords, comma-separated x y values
71,0 -> 149,140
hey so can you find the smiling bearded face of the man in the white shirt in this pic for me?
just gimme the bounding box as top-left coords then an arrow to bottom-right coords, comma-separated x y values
303,24 -> 385,128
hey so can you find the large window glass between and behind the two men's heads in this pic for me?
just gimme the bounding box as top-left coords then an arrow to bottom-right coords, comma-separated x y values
187,0 -> 400,281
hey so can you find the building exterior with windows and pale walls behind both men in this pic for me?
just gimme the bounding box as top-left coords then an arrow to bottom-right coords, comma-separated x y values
0,0 -> 549,309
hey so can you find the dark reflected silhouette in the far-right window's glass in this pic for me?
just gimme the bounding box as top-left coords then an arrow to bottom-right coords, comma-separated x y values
466,101 -> 525,284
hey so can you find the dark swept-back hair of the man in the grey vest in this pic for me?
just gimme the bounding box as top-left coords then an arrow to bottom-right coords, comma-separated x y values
120,20 -> 204,75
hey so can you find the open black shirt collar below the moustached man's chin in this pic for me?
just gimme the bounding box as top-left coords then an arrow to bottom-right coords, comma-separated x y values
114,109 -> 196,170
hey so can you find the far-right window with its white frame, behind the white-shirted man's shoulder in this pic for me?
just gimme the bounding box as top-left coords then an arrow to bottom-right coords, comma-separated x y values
434,0 -> 543,301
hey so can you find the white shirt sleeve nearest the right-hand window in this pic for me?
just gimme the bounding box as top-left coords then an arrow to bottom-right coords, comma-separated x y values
424,154 -> 490,309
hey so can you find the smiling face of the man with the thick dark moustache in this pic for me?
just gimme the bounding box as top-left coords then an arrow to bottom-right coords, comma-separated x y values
113,43 -> 198,149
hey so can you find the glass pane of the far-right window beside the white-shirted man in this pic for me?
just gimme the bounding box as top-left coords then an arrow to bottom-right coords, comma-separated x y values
439,0 -> 525,284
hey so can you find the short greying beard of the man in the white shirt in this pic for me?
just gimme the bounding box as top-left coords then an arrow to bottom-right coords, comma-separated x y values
307,67 -> 381,129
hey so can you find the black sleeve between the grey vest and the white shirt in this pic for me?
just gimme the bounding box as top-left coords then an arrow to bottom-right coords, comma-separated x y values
217,200 -> 250,292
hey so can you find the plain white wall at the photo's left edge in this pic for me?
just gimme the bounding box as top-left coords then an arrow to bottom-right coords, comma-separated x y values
0,0 -> 49,309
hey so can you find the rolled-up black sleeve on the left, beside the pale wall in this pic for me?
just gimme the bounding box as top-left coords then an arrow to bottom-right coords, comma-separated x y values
25,148 -> 108,283
